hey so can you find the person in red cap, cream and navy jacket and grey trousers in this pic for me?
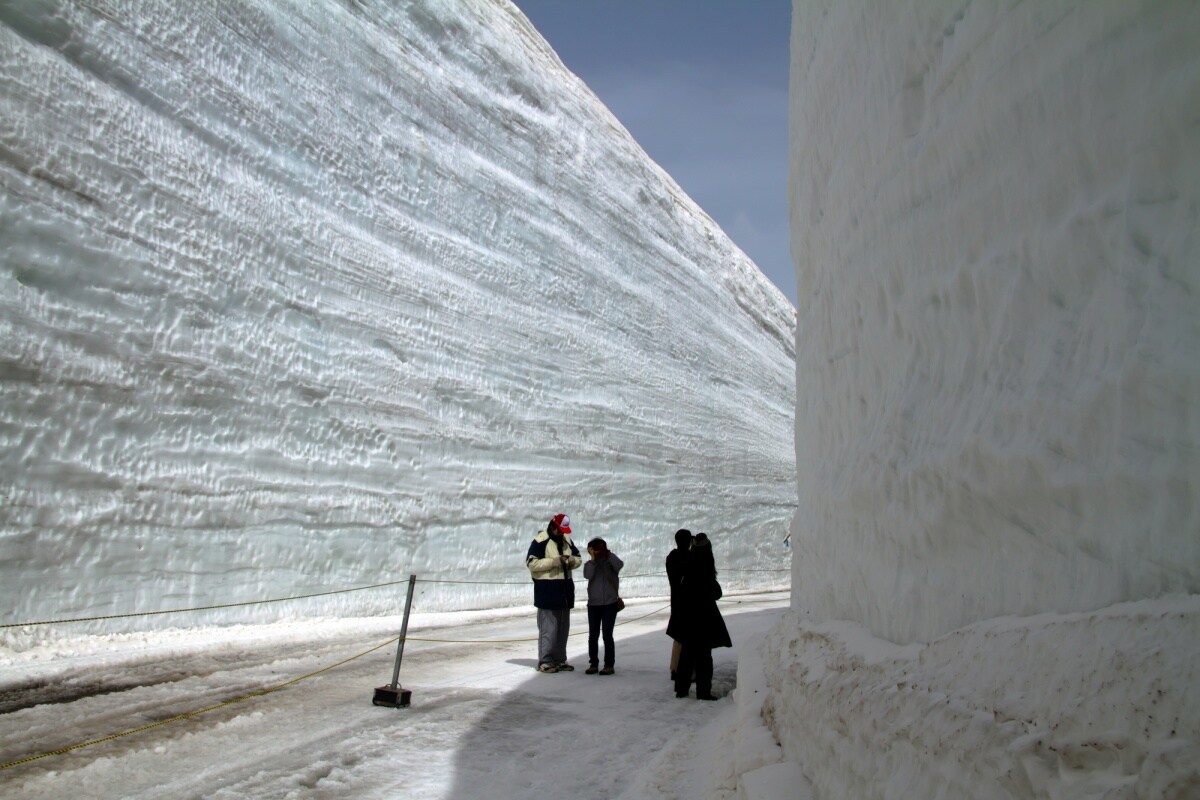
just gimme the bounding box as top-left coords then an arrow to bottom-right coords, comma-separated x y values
526,513 -> 583,672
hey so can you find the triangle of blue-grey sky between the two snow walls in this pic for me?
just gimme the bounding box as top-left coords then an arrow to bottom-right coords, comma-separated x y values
514,0 -> 796,305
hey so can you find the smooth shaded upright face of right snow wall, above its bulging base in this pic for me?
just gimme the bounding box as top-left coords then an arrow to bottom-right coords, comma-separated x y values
790,0 -> 1200,642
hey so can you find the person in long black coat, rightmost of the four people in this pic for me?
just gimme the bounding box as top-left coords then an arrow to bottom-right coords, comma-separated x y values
667,534 -> 733,700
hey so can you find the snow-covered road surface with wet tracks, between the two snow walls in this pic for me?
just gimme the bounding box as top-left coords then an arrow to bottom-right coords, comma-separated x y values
0,593 -> 788,799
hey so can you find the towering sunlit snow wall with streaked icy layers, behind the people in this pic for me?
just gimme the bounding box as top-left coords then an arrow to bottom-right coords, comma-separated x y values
0,0 -> 794,624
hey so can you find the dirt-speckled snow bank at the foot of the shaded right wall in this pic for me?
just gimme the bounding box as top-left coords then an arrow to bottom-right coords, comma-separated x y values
758,604 -> 1200,800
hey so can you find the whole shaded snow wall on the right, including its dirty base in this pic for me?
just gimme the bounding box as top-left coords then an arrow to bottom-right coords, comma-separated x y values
753,0 -> 1200,800
